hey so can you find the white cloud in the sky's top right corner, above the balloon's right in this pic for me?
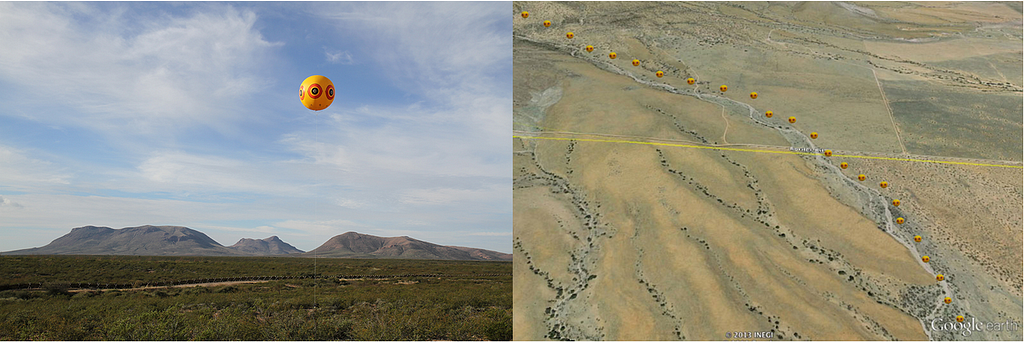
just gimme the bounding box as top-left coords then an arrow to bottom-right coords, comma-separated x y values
319,2 -> 511,91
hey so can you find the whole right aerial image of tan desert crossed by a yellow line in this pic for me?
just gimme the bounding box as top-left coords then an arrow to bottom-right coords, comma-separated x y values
509,1 -> 1024,341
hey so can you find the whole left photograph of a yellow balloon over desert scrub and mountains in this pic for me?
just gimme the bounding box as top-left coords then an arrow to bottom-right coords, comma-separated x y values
0,2 -> 512,341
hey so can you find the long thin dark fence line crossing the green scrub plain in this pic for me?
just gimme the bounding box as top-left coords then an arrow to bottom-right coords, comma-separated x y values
0,272 -> 512,291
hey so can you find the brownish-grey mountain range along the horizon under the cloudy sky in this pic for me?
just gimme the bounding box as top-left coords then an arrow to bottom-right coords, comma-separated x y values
0,225 -> 512,261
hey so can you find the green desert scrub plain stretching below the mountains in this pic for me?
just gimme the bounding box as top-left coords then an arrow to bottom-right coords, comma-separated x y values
0,256 -> 512,340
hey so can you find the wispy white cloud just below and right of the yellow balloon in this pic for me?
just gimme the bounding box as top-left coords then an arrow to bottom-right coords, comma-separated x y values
281,104 -> 512,181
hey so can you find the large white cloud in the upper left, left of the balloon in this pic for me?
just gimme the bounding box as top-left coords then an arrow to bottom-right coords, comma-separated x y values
0,2 -> 278,135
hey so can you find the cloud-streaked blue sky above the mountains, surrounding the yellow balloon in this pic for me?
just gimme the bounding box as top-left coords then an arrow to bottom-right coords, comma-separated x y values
0,2 -> 512,253
